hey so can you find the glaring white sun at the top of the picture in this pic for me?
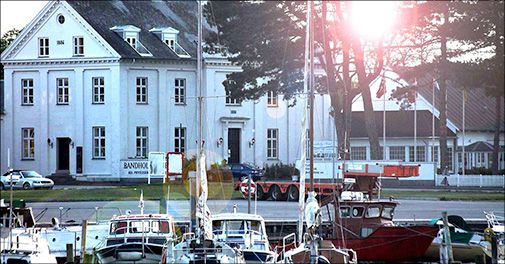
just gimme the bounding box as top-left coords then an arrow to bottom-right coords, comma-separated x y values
349,1 -> 399,39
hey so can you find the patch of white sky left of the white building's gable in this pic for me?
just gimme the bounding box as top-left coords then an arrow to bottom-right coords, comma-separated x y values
0,0 -> 48,36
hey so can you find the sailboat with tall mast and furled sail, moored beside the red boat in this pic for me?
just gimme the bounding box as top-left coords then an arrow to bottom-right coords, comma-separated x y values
280,1 -> 357,263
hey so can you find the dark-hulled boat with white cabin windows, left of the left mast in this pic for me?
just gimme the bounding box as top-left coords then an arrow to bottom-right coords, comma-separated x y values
94,213 -> 175,263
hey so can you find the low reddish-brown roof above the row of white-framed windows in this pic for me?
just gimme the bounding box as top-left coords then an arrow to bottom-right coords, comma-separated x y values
351,110 -> 456,138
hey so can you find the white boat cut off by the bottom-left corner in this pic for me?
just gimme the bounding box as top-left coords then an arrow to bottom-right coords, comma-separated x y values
0,229 -> 57,264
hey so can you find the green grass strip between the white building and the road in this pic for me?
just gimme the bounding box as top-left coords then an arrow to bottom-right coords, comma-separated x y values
0,183 -> 241,202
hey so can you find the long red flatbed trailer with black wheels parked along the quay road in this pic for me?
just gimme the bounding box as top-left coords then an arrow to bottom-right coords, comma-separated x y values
234,161 -> 419,201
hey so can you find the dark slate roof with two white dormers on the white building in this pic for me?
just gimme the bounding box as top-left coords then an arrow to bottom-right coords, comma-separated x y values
67,0 -> 205,60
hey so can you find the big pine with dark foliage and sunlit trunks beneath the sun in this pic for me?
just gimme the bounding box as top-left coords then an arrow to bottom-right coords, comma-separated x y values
205,1 -> 412,159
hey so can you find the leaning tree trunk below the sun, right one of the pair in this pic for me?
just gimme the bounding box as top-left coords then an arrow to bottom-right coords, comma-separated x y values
352,39 -> 381,160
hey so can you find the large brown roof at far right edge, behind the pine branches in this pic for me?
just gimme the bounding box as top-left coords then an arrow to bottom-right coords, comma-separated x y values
418,76 -> 505,131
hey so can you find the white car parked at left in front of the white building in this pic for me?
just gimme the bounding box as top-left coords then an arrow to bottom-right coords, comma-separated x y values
2,170 -> 54,190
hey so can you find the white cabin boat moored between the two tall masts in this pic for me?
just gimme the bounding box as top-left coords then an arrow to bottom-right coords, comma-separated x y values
211,208 -> 277,263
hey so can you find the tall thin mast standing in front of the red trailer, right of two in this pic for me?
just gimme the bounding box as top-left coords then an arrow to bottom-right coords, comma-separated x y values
309,1 -> 314,192
